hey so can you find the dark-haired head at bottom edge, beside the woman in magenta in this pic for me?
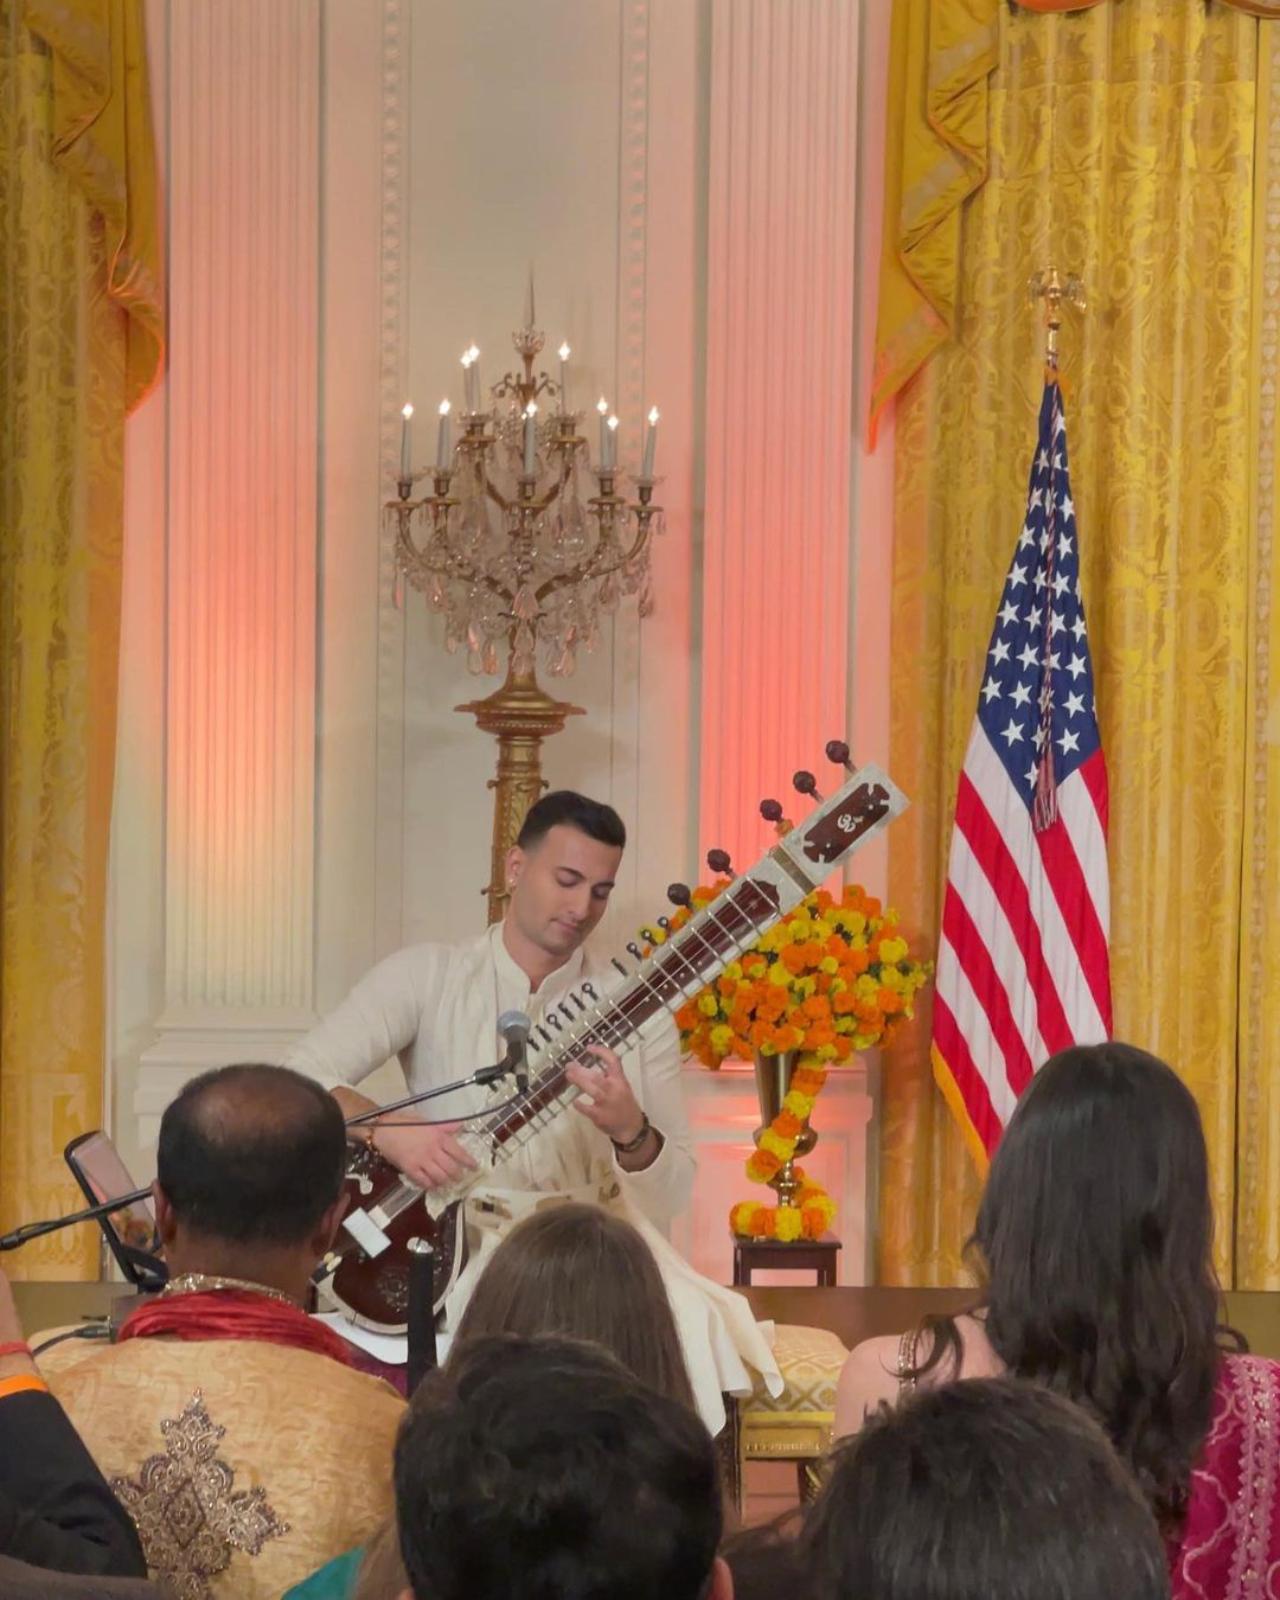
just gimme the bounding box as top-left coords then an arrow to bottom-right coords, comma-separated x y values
798,1378 -> 1170,1600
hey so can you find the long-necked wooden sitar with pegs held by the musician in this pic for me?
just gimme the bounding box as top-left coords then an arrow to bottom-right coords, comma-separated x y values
317,746 -> 907,1334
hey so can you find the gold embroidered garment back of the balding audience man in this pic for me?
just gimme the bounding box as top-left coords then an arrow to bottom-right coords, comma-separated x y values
46,1339 -> 405,1600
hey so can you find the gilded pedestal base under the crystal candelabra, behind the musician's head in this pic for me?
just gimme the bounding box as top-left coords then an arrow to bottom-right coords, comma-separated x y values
454,652 -> 582,923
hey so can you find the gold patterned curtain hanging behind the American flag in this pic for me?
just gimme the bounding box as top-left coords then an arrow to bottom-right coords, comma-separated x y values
880,0 -> 1260,1286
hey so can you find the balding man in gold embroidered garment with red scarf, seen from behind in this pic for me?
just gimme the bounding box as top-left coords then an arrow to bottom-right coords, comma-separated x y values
50,1066 -> 403,1600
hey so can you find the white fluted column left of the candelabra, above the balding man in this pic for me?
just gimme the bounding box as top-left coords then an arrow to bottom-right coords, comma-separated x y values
138,0 -> 322,1123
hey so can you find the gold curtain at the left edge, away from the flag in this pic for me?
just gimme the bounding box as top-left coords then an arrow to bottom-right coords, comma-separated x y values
0,0 -> 163,1277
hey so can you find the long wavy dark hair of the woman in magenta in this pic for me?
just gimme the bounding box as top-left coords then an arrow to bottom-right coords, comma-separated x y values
971,1043 -> 1221,1523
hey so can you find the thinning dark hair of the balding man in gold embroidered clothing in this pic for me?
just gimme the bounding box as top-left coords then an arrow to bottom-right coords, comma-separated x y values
155,1066 -> 347,1245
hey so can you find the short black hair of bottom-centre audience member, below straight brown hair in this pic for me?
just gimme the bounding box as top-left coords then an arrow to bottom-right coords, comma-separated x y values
395,1334 -> 723,1600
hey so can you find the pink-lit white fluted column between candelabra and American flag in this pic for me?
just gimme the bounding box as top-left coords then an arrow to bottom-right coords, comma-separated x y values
699,0 -> 857,869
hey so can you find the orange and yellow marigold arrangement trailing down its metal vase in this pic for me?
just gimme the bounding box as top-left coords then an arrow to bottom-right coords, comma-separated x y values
645,882 -> 930,1240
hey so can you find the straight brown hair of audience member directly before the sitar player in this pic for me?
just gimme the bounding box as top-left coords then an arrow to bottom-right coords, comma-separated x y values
454,1205 -> 693,1405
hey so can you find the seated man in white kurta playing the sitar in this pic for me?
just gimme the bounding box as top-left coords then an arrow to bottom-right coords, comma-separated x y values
288,790 -> 781,1430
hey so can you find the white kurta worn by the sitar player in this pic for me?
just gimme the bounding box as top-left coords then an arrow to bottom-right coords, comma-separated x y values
288,925 -> 781,1432
